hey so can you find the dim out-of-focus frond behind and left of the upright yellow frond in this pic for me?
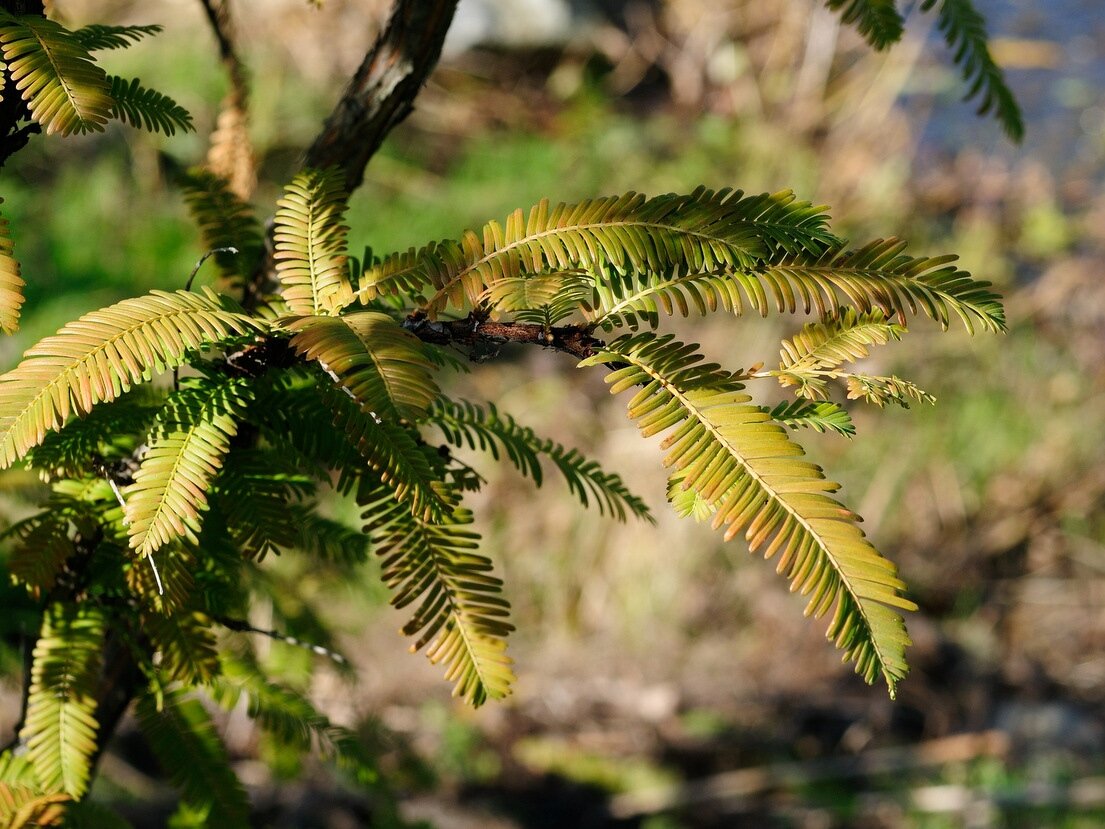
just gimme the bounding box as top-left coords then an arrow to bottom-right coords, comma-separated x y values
181,169 -> 264,282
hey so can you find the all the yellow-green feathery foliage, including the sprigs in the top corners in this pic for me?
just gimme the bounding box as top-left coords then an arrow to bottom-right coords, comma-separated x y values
0,0 -> 1018,827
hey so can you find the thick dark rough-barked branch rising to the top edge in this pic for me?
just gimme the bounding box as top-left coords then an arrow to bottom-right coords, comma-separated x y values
304,0 -> 457,192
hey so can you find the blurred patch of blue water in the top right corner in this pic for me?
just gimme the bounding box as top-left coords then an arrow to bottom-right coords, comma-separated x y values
919,0 -> 1105,178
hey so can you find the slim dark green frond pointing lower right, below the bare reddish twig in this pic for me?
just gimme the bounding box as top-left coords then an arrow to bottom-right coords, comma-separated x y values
429,398 -> 653,522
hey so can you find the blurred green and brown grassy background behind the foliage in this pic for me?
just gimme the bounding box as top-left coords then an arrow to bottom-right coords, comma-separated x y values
0,0 -> 1105,829
